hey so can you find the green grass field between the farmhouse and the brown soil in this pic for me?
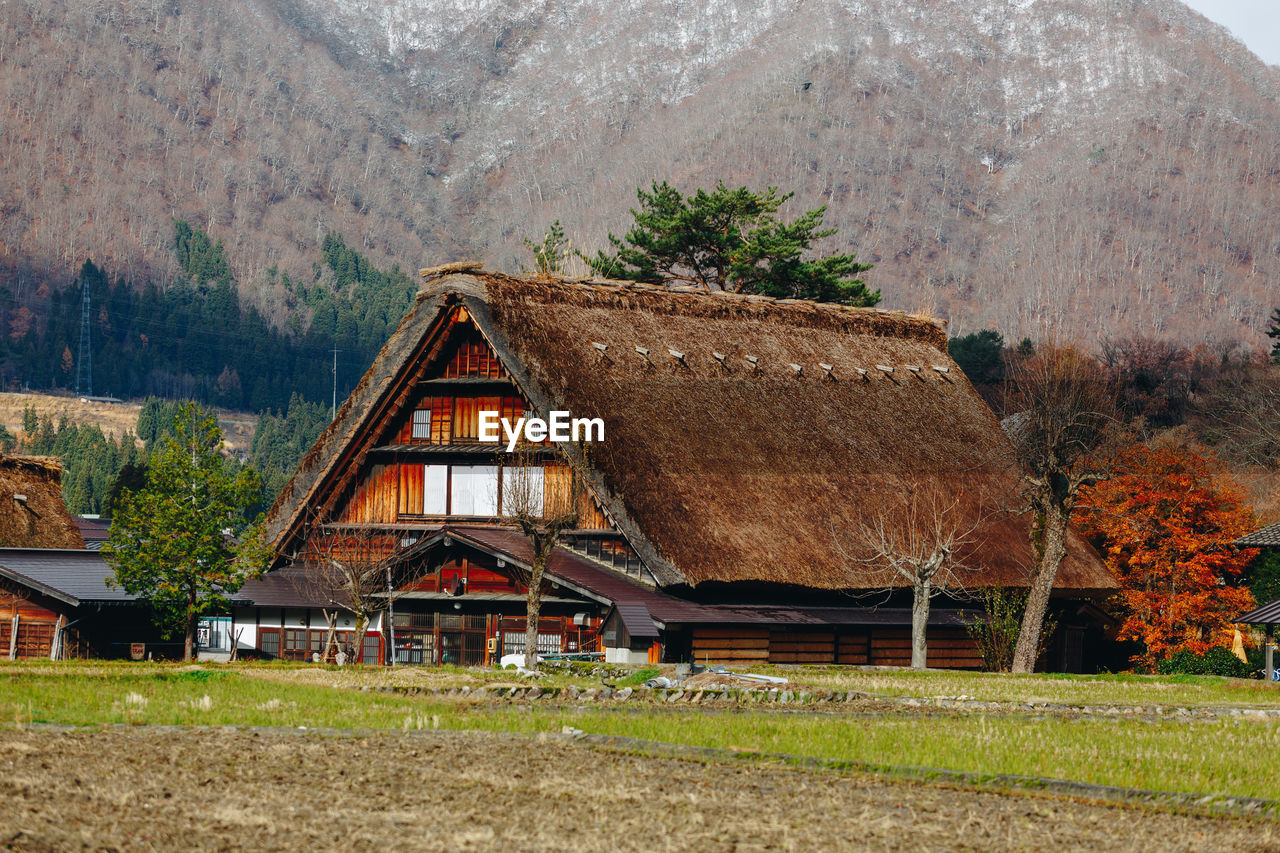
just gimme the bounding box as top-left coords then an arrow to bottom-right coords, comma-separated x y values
0,663 -> 1280,799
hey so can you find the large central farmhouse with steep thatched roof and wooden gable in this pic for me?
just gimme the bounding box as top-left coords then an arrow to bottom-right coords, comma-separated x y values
246,268 -> 1115,666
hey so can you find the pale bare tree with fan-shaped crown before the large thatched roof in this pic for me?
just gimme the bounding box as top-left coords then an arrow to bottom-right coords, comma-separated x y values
841,482 -> 982,670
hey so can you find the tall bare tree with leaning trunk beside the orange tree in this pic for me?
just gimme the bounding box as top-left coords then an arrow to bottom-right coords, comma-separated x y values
1005,343 -> 1121,672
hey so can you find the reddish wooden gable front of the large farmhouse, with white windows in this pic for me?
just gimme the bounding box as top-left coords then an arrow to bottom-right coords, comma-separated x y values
228,306 -> 643,665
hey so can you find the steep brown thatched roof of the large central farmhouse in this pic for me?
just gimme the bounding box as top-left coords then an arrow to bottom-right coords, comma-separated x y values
269,270 -> 1115,590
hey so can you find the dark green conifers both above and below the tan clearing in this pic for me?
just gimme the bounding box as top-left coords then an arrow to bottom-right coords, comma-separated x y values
0,220 -> 416,515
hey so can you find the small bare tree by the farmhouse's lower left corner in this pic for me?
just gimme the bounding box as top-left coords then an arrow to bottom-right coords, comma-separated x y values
294,519 -> 401,662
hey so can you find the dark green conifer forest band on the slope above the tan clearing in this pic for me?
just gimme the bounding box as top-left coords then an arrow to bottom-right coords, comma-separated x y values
0,220 -> 415,411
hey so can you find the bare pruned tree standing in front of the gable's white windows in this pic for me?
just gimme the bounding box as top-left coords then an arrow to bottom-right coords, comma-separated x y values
502,448 -> 579,670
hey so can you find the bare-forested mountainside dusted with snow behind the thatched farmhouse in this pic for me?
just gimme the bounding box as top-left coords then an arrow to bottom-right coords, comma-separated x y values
0,0 -> 1280,347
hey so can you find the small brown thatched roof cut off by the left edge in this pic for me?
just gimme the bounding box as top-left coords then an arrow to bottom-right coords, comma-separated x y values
0,455 -> 84,548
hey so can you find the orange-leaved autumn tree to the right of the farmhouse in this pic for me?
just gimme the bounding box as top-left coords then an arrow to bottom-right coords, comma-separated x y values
1079,446 -> 1257,670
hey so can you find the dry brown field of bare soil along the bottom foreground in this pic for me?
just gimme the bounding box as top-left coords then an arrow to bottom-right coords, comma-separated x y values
0,726 -> 1280,853
